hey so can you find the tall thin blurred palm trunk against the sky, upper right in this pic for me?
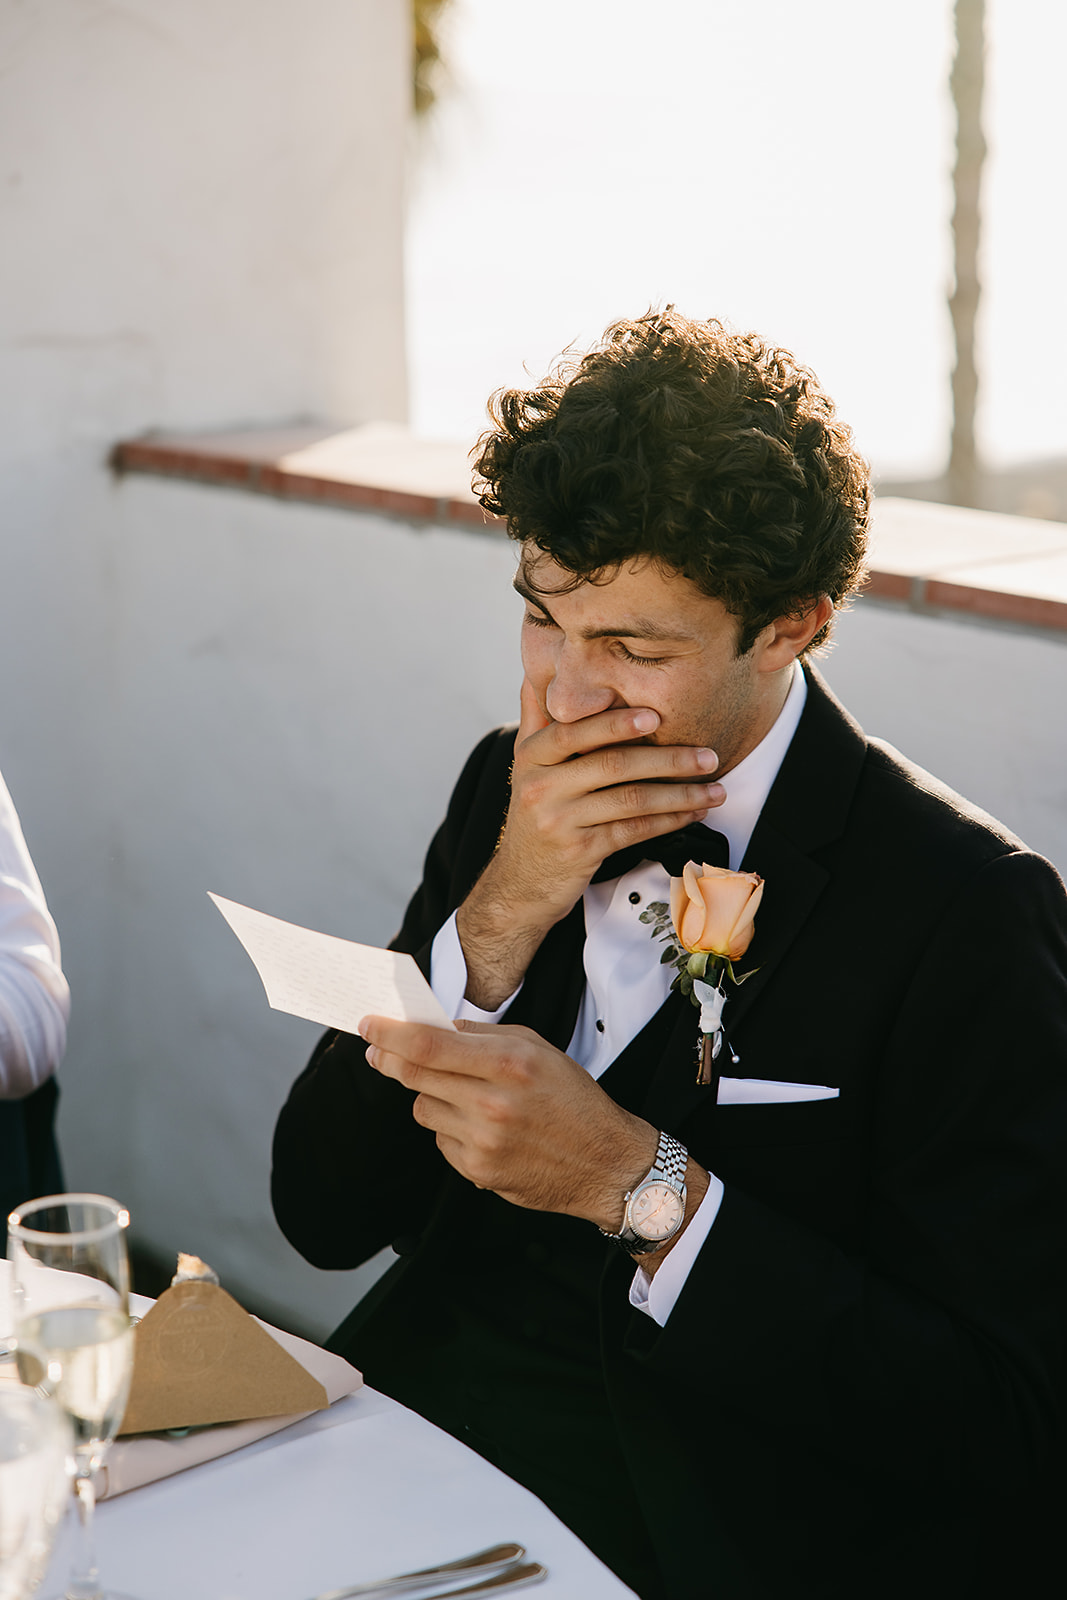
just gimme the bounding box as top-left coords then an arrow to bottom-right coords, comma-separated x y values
947,0 -> 985,506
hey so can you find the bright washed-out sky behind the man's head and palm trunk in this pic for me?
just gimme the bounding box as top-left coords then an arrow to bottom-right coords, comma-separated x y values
408,0 -> 1067,474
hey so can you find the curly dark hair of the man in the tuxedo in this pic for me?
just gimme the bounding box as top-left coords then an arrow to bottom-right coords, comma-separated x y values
475,306 -> 870,654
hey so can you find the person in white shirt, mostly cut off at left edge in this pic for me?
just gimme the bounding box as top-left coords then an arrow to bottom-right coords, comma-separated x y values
0,778 -> 70,1216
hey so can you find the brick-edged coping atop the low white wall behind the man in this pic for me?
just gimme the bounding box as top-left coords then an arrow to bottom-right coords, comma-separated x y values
112,422 -> 1067,632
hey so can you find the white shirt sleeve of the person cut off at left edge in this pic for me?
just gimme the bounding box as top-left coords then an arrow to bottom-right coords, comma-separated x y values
0,764 -> 70,1099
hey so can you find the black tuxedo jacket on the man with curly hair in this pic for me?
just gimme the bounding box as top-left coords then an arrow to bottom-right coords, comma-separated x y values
274,674 -> 1067,1600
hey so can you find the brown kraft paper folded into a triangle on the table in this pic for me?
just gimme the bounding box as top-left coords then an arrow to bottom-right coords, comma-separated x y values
120,1282 -> 330,1434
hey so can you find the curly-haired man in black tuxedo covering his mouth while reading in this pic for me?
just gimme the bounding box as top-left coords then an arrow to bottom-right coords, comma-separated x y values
274,312 -> 1067,1600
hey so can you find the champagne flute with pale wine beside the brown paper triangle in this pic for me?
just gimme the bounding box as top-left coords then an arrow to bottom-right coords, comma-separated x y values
8,1194 -> 133,1600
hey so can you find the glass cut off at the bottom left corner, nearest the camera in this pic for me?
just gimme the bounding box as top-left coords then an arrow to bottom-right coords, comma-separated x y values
0,1382 -> 74,1600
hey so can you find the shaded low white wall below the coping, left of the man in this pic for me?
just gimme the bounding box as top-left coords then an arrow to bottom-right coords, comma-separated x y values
60,477 -> 520,1333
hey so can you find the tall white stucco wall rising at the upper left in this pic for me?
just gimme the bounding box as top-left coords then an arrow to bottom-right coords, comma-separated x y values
0,0 -> 411,812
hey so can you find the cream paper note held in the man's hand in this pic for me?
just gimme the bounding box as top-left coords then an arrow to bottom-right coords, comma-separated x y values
208,891 -> 453,1034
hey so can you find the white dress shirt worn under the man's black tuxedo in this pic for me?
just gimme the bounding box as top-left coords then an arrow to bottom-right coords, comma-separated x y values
430,666 -> 808,1328
